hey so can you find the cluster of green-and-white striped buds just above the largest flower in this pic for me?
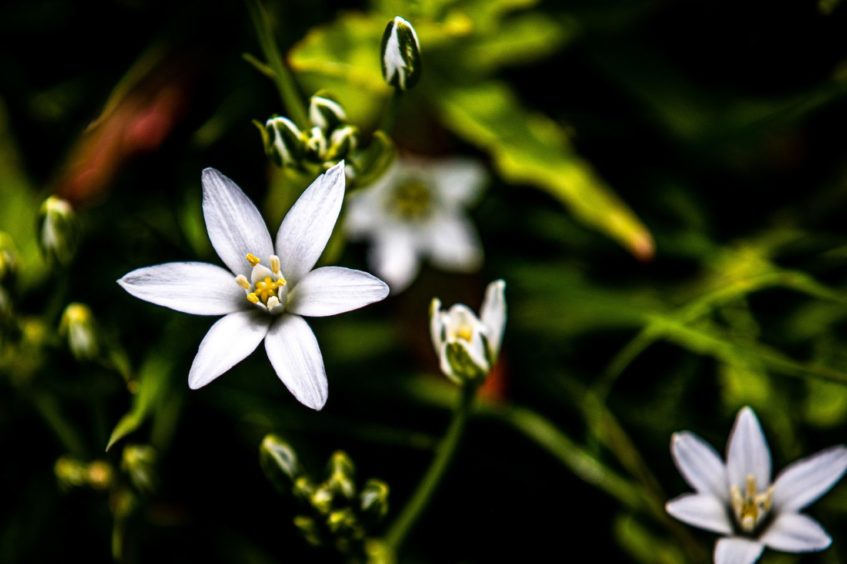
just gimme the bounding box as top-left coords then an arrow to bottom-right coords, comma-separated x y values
263,94 -> 358,170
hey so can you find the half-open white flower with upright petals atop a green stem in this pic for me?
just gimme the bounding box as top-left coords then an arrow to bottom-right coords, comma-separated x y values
429,280 -> 506,384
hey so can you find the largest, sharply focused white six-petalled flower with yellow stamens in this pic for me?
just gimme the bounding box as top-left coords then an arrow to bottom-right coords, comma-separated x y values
118,163 -> 388,409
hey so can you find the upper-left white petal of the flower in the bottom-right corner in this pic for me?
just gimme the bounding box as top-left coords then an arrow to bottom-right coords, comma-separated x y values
671,431 -> 729,503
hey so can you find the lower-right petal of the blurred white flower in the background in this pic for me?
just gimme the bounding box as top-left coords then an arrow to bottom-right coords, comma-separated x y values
428,214 -> 482,272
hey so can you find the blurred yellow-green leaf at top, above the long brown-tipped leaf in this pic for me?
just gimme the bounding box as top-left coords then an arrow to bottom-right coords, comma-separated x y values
458,13 -> 577,72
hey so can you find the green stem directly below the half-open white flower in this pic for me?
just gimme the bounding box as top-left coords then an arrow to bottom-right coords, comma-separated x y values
385,385 -> 477,553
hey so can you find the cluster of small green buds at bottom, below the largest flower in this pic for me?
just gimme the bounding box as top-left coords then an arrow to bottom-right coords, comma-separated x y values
259,435 -> 388,558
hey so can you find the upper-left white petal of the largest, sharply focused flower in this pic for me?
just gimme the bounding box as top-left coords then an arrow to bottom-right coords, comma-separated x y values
203,168 -> 273,276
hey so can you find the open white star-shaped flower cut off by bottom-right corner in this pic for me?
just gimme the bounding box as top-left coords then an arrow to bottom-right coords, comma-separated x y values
665,407 -> 847,564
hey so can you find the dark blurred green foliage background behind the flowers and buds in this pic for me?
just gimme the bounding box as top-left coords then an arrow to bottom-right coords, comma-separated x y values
0,0 -> 847,563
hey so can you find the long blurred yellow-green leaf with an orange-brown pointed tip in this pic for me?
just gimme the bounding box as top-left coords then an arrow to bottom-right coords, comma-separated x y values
436,82 -> 653,259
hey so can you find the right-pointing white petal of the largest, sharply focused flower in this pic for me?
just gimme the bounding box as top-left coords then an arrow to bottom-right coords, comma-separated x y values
288,266 -> 388,317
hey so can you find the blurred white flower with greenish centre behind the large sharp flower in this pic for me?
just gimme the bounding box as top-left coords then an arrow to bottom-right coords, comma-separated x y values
345,159 -> 486,292
